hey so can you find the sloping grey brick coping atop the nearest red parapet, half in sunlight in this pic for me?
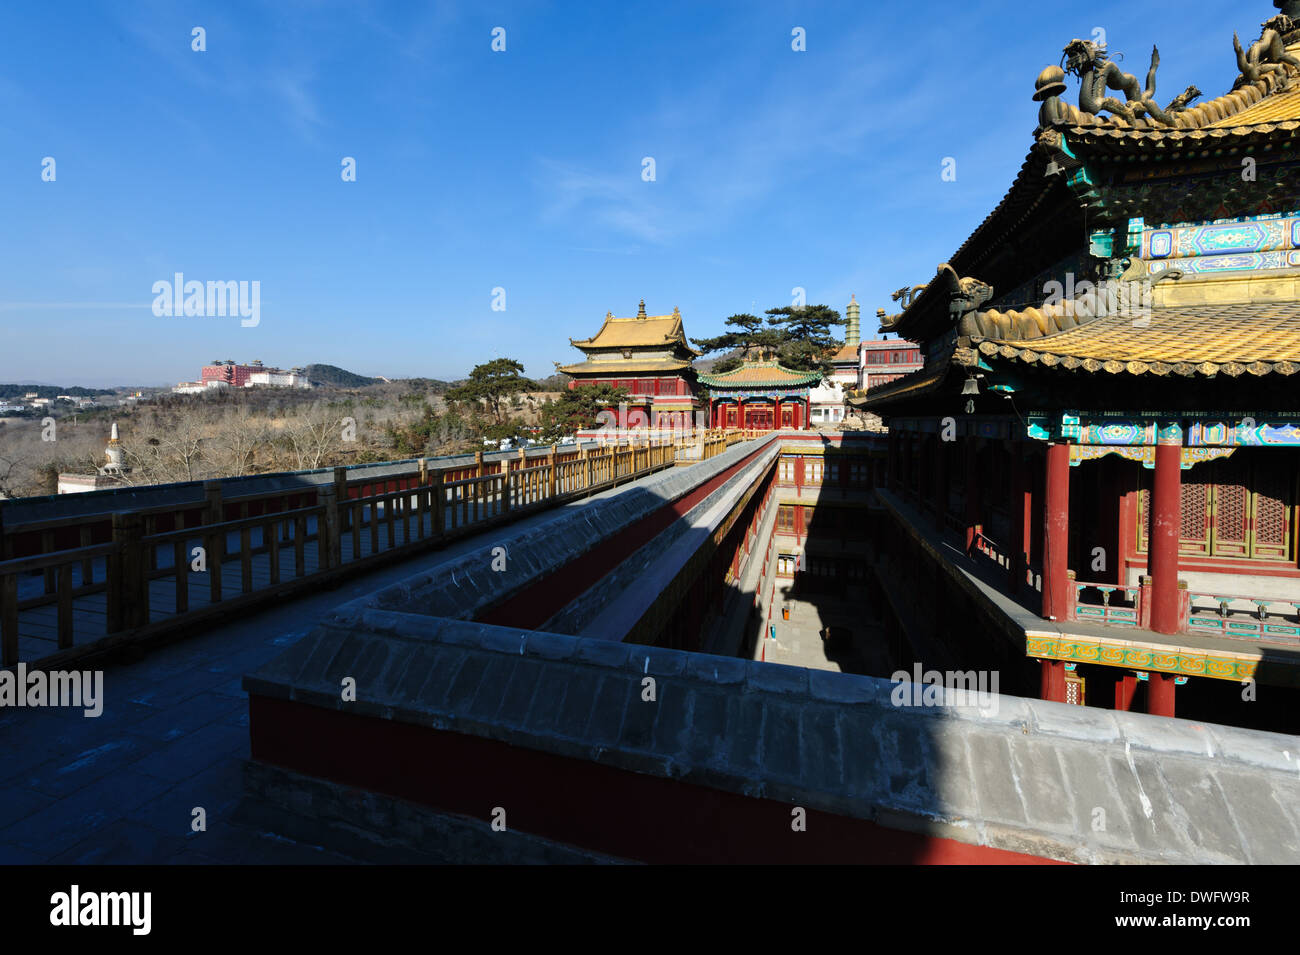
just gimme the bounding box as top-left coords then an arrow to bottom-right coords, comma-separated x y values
244,608 -> 1300,863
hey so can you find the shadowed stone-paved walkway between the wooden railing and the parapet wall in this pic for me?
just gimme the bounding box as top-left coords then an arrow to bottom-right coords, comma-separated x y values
0,470 -> 665,864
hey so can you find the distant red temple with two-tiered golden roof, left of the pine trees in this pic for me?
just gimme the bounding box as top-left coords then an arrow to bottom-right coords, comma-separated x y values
558,300 -> 699,429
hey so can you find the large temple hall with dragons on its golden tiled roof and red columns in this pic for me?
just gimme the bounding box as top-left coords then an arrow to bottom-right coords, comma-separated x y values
850,0 -> 1300,724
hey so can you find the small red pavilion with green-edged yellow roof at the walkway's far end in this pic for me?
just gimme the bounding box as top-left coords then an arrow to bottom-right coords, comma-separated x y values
698,355 -> 822,431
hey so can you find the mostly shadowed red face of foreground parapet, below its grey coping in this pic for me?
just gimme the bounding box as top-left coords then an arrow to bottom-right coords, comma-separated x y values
248,694 -> 1060,865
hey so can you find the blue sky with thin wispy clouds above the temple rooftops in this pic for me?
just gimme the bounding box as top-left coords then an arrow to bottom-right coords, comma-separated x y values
0,0 -> 1258,386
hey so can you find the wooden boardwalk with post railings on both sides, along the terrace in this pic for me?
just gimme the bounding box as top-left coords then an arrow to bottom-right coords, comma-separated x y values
0,431 -> 755,667
